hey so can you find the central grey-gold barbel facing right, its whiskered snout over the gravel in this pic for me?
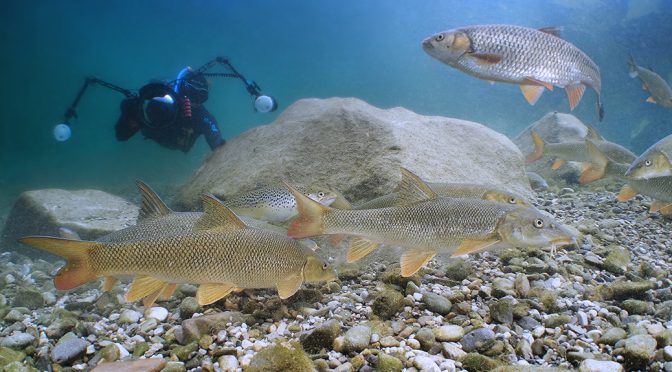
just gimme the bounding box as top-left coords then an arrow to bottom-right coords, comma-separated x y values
287,171 -> 574,277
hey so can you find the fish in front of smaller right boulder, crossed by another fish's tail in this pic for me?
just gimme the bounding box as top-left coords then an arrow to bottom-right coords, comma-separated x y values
525,131 -> 636,170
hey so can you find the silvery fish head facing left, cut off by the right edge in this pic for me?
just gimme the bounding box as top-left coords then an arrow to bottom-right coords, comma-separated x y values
625,134 -> 672,179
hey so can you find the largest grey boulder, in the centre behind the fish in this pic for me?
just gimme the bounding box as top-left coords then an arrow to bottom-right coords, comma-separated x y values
173,98 -> 531,210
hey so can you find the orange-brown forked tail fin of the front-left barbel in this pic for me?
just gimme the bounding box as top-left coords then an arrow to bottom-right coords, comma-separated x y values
19,236 -> 99,290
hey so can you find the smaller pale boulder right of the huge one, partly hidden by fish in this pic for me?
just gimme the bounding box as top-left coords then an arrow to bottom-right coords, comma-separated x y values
513,112 -> 588,186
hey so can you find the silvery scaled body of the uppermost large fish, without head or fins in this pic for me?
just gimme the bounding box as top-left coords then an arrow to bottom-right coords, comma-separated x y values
457,25 -> 601,93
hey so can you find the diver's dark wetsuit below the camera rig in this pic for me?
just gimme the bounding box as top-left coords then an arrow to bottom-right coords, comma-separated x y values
114,79 -> 225,153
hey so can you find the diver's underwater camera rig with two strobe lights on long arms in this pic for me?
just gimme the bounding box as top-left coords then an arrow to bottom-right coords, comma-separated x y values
53,57 -> 278,142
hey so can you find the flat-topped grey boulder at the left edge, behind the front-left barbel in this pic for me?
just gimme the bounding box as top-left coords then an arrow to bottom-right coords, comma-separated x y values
0,189 -> 138,256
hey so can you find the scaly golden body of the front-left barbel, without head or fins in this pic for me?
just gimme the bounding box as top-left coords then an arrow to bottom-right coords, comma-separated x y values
91,228 -> 306,288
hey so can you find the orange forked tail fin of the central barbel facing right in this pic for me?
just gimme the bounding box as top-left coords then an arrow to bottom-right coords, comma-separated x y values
285,182 -> 331,239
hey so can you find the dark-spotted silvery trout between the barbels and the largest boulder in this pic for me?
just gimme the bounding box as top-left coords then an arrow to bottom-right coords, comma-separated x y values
222,185 -> 339,222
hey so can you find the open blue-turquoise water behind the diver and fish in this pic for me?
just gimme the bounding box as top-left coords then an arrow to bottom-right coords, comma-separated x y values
0,0 -> 672,209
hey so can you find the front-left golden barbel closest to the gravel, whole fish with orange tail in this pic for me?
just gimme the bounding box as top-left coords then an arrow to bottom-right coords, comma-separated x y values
19,194 -> 336,305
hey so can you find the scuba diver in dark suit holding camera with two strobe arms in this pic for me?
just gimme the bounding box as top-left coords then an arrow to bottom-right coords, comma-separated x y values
54,57 -> 277,153
